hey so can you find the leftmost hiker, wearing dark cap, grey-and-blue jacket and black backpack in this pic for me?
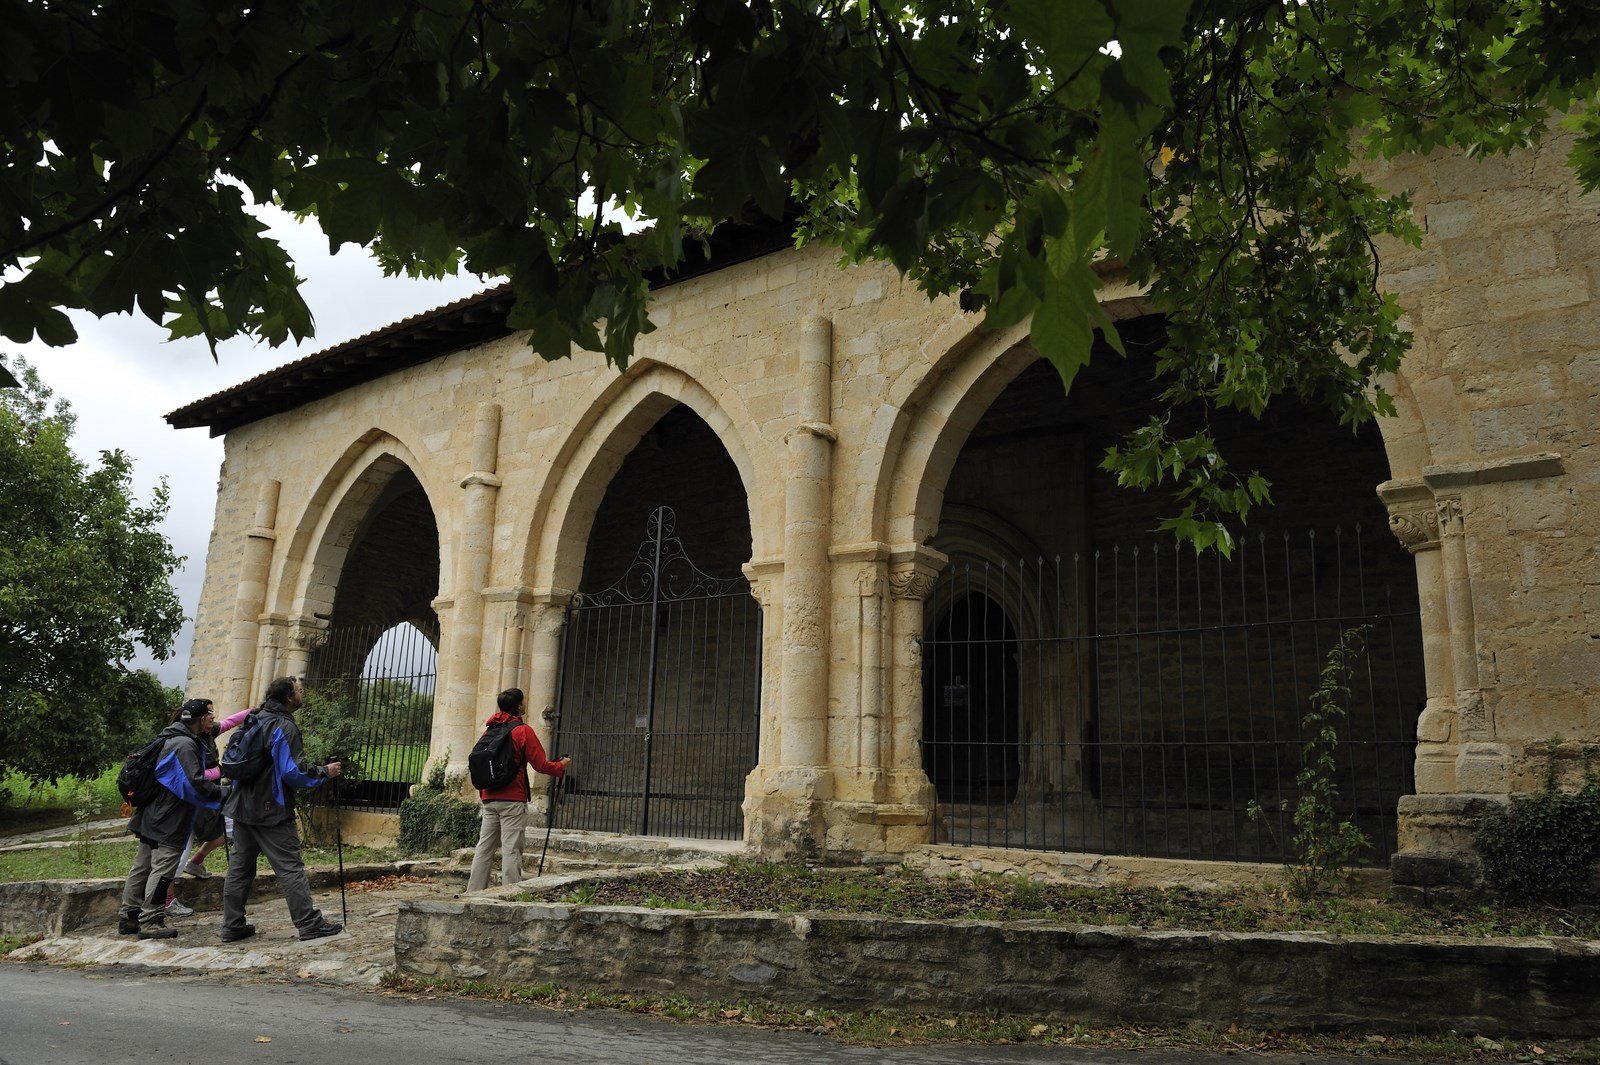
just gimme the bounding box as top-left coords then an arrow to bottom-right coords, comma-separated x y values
117,705 -> 224,939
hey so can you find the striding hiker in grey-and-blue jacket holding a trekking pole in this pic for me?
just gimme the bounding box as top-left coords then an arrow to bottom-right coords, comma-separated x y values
222,676 -> 344,943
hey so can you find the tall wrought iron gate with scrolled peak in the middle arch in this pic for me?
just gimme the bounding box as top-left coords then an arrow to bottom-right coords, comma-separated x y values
552,507 -> 762,840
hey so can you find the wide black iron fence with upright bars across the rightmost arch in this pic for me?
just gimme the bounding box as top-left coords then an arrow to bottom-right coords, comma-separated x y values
923,526 -> 1424,862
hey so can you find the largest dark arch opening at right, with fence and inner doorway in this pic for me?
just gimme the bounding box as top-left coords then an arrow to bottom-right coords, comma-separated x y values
923,320 -> 1424,864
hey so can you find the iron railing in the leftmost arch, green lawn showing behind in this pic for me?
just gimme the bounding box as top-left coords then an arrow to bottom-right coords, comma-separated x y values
304,625 -> 438,809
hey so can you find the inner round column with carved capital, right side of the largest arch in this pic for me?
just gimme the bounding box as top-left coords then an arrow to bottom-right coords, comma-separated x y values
1378,480 -> 1461,795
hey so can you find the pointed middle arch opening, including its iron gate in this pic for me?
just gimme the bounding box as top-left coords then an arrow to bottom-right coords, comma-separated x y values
552,405 -> 762,838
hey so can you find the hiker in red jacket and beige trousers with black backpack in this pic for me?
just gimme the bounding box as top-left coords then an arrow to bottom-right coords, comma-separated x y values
467,688 -> 573,891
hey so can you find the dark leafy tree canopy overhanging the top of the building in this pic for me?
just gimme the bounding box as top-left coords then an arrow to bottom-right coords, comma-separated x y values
9,0 -> 1600,539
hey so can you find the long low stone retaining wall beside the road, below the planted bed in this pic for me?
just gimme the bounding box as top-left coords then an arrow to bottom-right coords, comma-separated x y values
395,899 -> 1600,1036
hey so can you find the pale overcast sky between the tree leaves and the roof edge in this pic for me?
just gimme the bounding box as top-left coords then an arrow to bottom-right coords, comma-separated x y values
17,211 -> 488,688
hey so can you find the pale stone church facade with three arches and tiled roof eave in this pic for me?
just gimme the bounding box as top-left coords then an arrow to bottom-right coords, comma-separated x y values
168,135 -> 1600,891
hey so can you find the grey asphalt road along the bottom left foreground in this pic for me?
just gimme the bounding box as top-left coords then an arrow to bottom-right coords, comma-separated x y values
0,963 -> 1370,1065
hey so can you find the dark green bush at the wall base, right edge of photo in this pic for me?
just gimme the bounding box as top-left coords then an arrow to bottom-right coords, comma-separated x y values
1474,739 -> 1600,905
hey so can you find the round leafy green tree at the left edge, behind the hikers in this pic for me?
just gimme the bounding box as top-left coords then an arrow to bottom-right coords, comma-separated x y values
0,361 -> 184,782
